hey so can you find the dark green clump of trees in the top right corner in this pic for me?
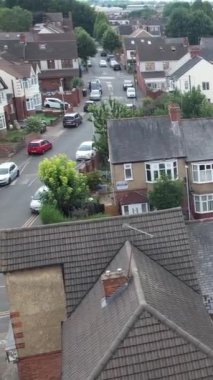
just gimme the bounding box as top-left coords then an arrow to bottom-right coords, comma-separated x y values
163,0 -> 213,45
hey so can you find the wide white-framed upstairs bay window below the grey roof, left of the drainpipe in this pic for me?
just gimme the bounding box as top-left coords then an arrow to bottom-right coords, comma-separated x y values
145,160 -> 178,183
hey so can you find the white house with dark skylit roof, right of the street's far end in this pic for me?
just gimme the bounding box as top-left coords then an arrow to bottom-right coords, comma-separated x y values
136,37 -> 190,95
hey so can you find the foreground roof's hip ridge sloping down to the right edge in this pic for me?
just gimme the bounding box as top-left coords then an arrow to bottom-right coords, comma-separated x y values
145,304 -> 213,358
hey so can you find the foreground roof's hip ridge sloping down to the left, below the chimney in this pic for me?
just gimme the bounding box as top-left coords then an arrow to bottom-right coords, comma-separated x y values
87,305 -> 144,380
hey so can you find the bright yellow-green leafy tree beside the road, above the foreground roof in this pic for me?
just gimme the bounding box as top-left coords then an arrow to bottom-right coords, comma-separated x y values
39,154 -> 89,216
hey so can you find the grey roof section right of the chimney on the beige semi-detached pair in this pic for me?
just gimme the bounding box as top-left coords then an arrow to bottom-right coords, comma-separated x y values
181,118 -> 213,162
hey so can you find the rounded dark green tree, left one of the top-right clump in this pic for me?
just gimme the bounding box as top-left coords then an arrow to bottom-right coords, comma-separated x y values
166,8 -> 190,37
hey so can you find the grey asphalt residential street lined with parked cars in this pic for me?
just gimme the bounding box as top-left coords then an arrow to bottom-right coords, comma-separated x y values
0,54 -> 141,380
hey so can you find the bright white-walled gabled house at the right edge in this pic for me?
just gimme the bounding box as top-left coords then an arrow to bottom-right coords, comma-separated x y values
168,56 -> 213,103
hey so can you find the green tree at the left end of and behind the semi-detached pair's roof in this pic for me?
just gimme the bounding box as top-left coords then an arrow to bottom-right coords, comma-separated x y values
91,99 -> 143,164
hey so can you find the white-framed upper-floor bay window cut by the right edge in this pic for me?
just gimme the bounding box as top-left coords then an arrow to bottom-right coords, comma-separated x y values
192,161 -> 213,183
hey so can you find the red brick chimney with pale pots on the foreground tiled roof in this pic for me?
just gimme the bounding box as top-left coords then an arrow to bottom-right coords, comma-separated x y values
101,268 -> 129,298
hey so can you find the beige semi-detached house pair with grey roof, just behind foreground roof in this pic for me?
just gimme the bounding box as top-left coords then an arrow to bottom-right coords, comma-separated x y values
108,106 -> 213,218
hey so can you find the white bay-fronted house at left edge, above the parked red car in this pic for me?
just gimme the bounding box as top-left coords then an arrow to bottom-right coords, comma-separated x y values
0,58 -> 42,124
